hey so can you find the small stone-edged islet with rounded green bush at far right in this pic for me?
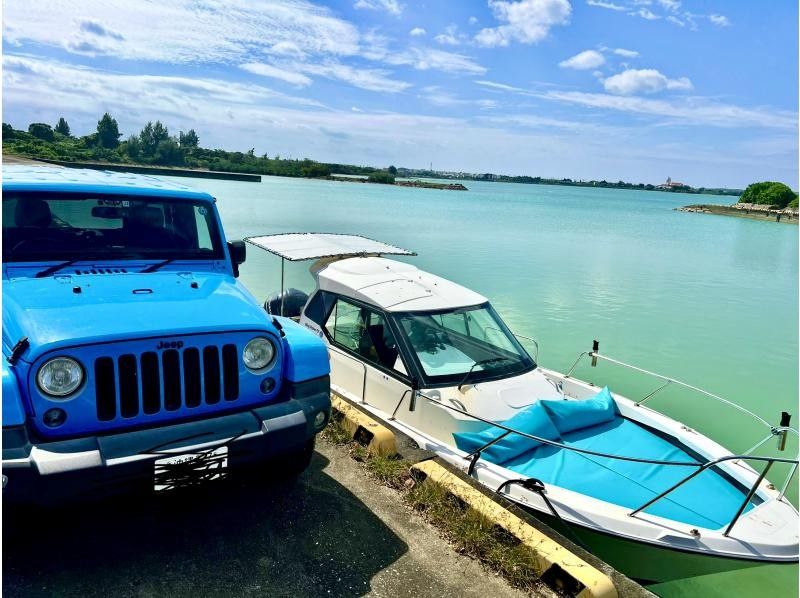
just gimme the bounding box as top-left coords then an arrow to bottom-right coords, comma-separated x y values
676,181 -> 798,224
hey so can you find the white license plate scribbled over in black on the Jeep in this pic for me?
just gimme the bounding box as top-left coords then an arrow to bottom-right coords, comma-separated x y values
153,446 -> 228,492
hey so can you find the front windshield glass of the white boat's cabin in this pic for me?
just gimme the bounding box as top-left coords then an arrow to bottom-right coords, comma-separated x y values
395,303 -> 536,385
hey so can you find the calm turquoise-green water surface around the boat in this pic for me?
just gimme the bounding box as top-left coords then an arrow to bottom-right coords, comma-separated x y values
166,177 -> 800,595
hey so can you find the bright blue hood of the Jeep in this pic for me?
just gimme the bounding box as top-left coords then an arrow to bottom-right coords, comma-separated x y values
3,271 -> 273,361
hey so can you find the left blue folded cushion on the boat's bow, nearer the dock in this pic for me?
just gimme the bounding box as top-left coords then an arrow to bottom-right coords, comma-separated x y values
453,401 -> 560,465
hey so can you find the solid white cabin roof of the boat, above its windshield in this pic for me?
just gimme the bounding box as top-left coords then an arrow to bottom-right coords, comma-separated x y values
314,257 -> 488,311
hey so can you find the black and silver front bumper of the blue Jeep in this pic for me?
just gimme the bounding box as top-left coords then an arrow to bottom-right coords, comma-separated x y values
2,376 -> 331,504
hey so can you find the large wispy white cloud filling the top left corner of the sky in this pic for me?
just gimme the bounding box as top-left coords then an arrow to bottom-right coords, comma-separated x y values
3,0 -> 359,64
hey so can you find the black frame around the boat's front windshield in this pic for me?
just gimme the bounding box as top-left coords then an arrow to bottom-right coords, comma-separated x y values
387,301 -> 537,388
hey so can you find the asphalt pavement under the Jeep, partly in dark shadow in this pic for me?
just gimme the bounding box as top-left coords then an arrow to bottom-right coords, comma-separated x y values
2,441 -> 522,598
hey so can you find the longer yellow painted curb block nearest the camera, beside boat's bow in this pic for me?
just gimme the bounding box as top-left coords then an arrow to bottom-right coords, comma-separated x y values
412,461 -> 617,598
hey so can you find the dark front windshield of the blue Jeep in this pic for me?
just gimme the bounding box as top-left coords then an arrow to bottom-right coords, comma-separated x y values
3,192 -> 224,262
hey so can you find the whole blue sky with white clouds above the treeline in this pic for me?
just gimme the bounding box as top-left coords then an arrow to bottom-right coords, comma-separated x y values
3,0 -> 798,188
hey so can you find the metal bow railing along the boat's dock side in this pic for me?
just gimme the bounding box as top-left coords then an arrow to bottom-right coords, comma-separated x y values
416,390 -> 800,536
